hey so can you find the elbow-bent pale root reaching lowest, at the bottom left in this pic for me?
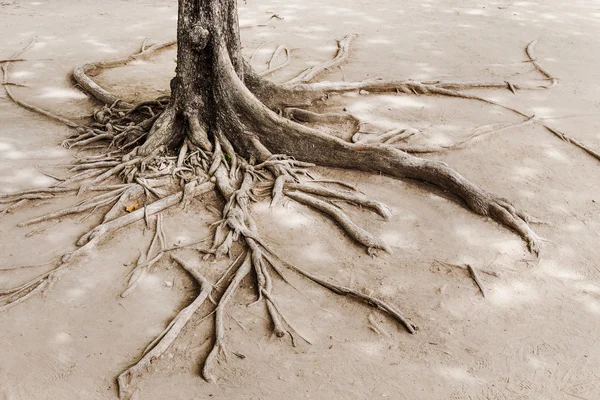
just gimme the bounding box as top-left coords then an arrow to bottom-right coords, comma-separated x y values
117,255 -> 213,400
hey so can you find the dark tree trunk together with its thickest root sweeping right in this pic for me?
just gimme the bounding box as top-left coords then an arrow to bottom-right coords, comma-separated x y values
131,0 -> 539,253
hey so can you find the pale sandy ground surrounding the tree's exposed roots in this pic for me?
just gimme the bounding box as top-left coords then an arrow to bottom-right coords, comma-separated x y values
0,0 -> 600,400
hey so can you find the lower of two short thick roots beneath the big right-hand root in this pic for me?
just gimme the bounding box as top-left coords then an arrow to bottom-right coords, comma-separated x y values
284,191 -> 392,255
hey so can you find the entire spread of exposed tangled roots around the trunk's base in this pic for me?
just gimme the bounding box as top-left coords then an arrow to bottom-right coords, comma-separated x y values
0,28 -> 600,399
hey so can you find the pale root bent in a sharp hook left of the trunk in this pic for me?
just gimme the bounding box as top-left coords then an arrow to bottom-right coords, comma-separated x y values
73,40 -> 177,108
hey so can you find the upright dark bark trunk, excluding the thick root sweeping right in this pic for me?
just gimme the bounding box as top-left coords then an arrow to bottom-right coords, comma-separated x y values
138,0 -> 244,155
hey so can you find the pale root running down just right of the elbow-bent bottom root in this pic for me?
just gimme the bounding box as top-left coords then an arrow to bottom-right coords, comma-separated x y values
202,252 -> 252,382
